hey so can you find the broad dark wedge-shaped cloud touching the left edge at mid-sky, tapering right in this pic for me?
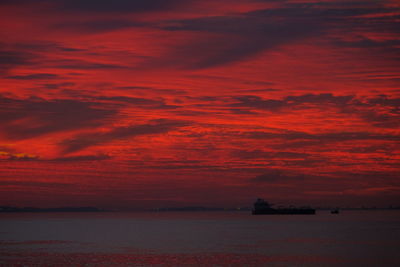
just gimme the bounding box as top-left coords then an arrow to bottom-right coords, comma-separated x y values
0,96 -> 117,140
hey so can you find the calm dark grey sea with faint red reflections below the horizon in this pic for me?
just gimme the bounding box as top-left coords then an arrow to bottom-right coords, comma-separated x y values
0,210 -> 400,266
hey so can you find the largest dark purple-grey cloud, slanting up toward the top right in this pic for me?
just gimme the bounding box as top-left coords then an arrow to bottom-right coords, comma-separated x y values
151,2 -> 400,69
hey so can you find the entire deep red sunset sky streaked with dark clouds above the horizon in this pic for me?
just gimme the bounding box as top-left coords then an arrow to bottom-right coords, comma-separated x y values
0,0 -> 400,209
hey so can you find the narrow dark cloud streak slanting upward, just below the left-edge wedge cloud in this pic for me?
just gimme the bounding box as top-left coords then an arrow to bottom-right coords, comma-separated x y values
60,119 -> 189,153
